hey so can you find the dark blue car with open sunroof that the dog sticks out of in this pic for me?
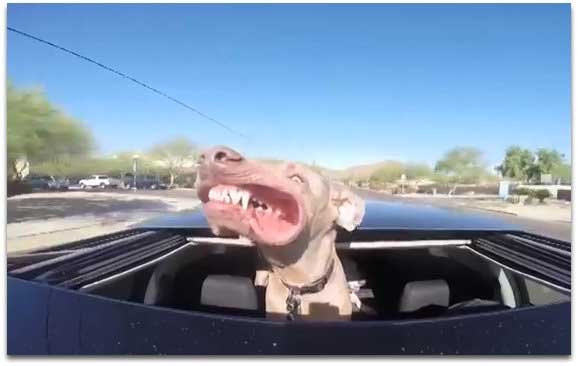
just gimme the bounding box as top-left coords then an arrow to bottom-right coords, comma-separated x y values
7,202 -> 571,356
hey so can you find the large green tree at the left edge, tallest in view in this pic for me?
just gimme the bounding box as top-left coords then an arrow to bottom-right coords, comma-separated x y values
6,82 -> 94,179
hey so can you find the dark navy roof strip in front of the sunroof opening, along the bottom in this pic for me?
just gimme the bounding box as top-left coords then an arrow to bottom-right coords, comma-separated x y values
6,276 -> 572,356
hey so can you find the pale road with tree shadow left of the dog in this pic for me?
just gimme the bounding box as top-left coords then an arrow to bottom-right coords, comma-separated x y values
6,190 -> 199,252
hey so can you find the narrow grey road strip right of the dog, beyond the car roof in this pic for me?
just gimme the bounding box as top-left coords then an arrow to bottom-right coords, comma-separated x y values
356,190 -> 572,241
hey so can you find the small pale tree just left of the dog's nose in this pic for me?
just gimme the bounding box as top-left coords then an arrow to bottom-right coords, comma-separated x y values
149,137 -> 197,185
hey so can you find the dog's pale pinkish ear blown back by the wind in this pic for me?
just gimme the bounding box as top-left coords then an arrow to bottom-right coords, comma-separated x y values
331,184 -> 365,231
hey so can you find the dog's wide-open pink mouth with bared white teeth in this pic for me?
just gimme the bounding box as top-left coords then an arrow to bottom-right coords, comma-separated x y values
199,184 -> 303,245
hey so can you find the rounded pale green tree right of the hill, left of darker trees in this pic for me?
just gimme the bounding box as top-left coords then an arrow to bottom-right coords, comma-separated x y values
434,147 -> 487,183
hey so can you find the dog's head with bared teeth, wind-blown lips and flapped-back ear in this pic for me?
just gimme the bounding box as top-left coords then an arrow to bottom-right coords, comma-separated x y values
197,146 -> 364,247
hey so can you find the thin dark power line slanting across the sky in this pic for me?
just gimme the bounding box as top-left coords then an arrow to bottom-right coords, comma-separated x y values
7,27 -> 249,140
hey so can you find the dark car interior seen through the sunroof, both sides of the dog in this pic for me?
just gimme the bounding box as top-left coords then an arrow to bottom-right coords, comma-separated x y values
81,244 -> 544,321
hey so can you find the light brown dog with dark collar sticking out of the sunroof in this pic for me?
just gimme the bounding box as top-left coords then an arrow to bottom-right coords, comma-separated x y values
198,146 -> 365,320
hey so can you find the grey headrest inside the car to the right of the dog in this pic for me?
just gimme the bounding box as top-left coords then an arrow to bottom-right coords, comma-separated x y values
399,280 -> 450,312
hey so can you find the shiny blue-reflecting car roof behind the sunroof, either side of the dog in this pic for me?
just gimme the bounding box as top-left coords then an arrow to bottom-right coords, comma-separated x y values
137,201 -> 519,231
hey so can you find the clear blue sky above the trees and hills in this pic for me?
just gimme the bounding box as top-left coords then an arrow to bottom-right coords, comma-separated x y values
7,4 -> 571,167
